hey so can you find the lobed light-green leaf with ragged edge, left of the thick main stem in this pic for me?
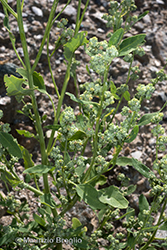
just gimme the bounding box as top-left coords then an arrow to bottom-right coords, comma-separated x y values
4,75 -> 35,97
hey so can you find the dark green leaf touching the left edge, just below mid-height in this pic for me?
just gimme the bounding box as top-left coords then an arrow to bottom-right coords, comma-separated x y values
0,131 -> 22,158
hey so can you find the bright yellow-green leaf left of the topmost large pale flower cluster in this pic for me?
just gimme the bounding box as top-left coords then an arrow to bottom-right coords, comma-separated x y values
64,31 -> 88,61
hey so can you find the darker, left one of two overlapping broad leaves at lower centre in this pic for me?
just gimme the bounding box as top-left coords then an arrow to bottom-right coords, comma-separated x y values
76,184 -> 106,209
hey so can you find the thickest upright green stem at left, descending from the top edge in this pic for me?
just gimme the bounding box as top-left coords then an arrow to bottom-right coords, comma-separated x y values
17,0 -> 50,193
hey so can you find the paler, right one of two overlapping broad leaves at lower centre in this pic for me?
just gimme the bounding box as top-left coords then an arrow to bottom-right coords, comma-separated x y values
99,186 -> 129,209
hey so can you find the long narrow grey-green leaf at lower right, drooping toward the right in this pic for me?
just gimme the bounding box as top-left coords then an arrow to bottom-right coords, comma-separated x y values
116,156 -> 154,178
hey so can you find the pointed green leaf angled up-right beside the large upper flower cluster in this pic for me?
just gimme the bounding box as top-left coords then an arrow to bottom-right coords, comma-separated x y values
119,34 -> 146,56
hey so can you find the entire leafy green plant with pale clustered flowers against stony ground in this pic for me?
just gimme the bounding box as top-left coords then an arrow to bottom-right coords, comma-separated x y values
0,0 -> 167,250
